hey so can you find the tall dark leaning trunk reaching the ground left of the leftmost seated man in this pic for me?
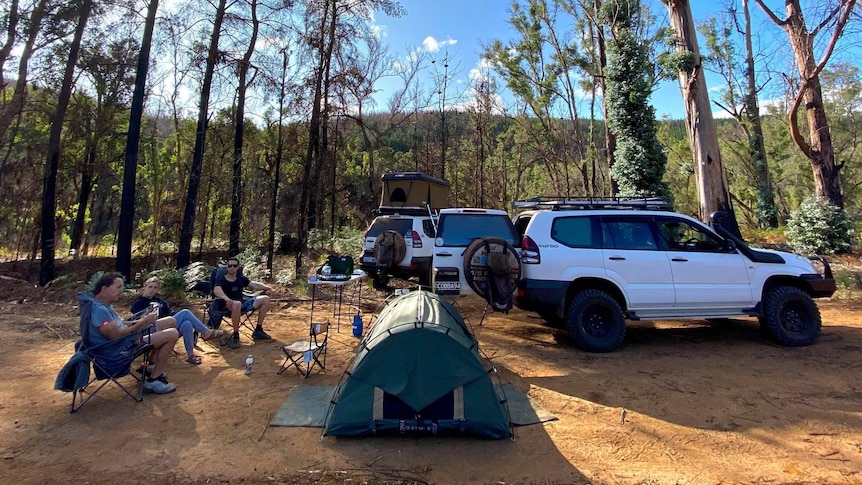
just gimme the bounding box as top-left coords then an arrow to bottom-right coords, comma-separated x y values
39,0 -> 93,286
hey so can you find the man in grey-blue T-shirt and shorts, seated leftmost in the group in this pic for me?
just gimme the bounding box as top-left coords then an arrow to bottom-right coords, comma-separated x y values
87,273 -> 180,394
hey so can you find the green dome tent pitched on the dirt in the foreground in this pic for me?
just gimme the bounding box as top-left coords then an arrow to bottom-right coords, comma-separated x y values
323,290 -> 512,439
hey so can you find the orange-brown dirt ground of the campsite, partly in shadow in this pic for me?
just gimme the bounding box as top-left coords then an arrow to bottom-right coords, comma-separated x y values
0,260 -> 862,484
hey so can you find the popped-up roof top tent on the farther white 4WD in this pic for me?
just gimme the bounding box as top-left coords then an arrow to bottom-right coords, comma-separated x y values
379,172 -> 456,214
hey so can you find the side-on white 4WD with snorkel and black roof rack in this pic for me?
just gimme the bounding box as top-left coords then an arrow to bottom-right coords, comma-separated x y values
515,199 -> 835,352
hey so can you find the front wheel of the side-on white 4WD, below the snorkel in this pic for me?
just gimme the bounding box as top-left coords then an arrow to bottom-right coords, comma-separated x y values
760,286 -> 822,347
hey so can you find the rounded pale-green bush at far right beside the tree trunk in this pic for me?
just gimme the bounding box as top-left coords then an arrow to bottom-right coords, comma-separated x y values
786,196 -> 854,254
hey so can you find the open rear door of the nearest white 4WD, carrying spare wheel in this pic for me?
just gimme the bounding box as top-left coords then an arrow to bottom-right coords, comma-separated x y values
432,208 -> 520,311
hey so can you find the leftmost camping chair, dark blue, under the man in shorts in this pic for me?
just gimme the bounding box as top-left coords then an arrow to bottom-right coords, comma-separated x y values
54,291 -> 153,413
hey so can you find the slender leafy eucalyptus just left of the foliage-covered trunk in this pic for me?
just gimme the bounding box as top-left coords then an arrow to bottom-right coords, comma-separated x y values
484,0 -> 595,195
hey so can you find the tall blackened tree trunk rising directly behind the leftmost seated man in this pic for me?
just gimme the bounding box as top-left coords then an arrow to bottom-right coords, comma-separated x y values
116,0 -> 159,281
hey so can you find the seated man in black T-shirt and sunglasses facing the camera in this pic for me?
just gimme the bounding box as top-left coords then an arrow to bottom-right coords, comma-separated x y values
213,257 -> 273,349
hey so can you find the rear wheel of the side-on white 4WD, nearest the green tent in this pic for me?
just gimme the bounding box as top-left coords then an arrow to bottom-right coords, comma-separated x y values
566,290 -> 626,352
